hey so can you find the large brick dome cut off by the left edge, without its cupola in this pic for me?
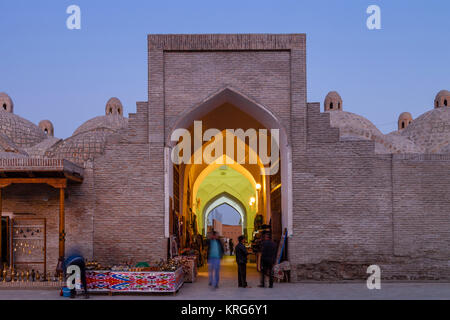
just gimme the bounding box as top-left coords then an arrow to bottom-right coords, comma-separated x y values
0,108 -> 47,147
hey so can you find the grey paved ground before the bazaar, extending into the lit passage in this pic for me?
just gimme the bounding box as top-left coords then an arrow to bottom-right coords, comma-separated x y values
0,257 -> 450,300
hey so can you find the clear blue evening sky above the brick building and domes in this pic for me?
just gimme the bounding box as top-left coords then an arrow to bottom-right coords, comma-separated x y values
0,0 -> 450,138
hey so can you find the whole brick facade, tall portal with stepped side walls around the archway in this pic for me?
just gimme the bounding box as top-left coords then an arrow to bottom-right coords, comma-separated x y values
3,34 -> 450,281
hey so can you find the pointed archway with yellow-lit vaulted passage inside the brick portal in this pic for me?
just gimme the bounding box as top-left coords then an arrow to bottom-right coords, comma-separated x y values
165,88 -> 292,260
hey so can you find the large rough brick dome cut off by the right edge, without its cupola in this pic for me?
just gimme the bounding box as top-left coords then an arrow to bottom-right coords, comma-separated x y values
401,108 -> 450,153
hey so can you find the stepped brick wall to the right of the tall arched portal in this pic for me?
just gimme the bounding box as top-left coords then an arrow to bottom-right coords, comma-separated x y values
289,104 -> 450,280
